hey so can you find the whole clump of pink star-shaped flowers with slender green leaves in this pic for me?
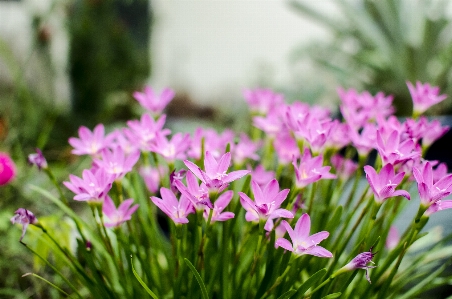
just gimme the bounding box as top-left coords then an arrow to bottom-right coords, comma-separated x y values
9,83 -> 452,298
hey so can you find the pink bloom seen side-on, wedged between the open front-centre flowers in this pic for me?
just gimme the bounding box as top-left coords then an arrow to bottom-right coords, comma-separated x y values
174,172 -> 213,210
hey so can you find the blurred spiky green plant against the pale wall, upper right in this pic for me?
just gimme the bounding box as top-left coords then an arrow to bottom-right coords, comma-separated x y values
288,0 -> 452,115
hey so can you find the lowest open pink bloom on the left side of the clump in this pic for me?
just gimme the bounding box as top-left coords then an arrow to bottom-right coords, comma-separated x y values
102,196 -> 139,227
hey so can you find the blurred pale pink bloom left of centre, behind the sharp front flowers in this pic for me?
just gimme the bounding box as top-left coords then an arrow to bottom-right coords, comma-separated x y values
149,133 -> 190,163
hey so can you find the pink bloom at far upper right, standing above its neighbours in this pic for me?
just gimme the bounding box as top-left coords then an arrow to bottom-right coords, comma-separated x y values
406,81 -> 447,115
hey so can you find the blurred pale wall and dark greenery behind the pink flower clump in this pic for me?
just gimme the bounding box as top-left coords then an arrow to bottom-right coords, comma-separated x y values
0,0 -> 452,298
